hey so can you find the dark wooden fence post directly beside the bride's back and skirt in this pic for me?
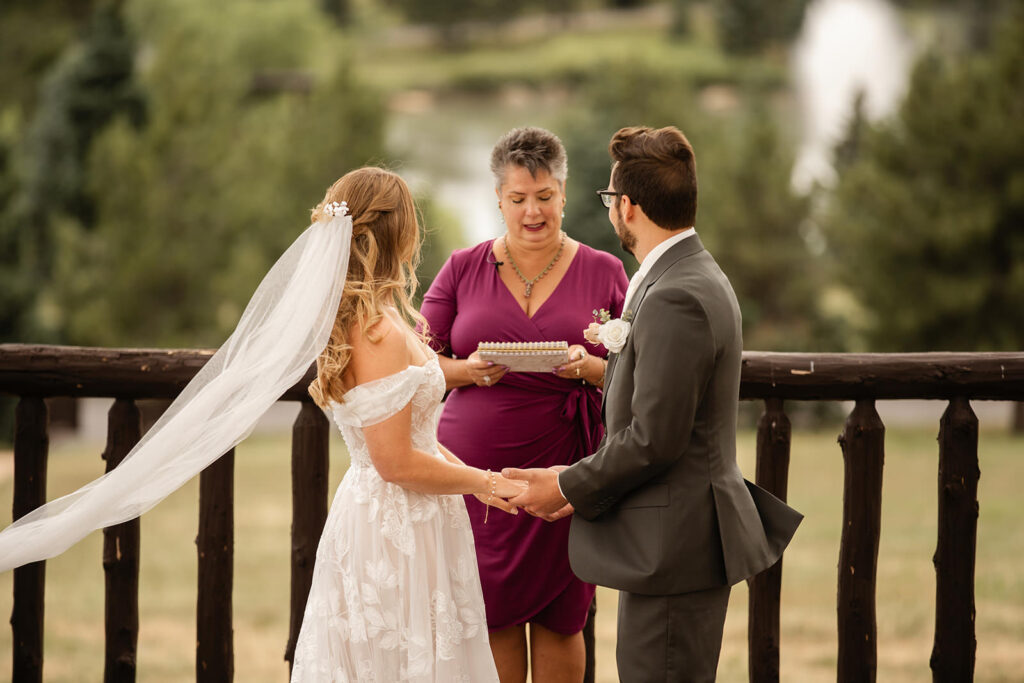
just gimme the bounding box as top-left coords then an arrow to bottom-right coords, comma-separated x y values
285,400 -> 331,671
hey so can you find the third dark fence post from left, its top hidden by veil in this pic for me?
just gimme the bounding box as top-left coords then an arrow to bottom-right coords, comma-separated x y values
196,449 -> 234,683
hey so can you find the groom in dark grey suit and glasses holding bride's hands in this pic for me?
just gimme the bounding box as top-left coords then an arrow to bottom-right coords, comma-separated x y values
502,127 -> 802,683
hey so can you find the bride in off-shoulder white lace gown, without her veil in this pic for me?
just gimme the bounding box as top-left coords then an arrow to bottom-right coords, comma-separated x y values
292,169 -> 521,683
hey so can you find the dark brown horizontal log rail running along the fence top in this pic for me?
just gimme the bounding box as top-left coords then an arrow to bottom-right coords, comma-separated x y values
6,344 -> 1024,400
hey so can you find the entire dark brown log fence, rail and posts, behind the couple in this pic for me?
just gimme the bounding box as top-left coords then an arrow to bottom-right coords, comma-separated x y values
0,344 -> 1024,683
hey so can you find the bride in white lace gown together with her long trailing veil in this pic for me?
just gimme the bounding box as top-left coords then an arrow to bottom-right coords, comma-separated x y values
0,168 -> 523,683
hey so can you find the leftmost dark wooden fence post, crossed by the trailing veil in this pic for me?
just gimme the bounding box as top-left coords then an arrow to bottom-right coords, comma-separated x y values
10,396 -> 49,683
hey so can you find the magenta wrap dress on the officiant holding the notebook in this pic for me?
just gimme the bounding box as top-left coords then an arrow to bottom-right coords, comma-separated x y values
421,241 -> 629,634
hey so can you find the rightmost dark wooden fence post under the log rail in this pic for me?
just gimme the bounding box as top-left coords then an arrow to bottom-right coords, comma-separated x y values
931,398 -> 981,683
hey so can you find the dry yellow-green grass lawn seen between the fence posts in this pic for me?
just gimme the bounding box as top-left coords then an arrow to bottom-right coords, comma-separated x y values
0,413 -> 1024,683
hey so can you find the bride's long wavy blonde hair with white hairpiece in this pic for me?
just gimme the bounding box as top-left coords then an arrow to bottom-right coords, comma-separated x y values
309,167 -> 427,408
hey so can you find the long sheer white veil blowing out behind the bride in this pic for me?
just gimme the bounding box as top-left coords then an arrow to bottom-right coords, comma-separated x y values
0,211 -> 352,571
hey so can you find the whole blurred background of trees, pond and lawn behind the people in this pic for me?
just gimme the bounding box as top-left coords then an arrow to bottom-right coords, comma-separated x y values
0,0 -> 1024,681
